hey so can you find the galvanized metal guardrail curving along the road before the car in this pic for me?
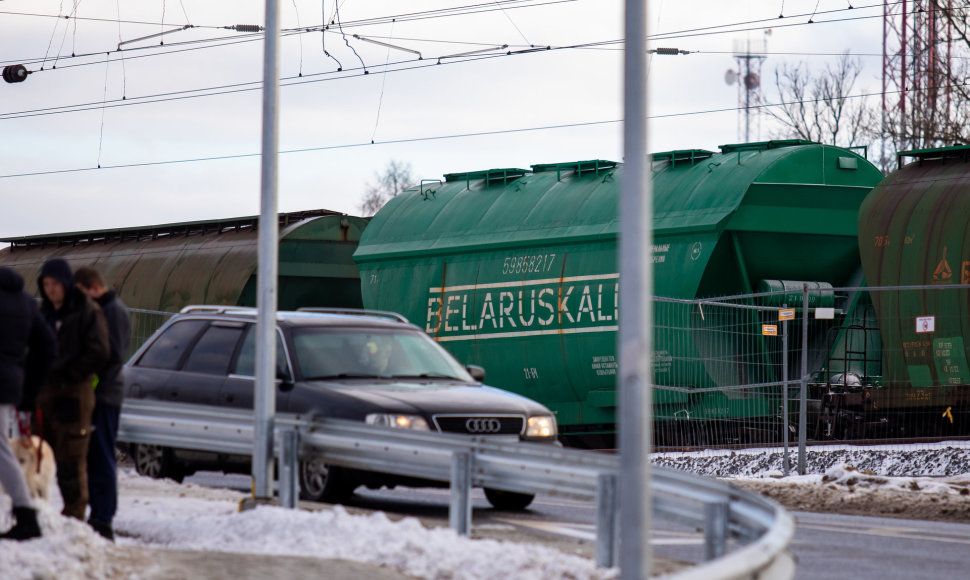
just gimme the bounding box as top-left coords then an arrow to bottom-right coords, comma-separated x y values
118,400 -> 795,580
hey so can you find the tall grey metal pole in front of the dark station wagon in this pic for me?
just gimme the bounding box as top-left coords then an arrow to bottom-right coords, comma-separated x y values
253,0 -> 280,498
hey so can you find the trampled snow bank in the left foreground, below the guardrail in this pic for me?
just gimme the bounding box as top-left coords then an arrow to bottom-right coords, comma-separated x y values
0,470 -> 617,580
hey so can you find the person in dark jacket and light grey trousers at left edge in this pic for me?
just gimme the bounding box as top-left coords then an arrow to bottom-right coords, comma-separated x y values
0,267 -> 57,540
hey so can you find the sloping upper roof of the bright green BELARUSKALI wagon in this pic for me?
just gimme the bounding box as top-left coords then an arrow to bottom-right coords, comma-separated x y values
355,141 -> 882,262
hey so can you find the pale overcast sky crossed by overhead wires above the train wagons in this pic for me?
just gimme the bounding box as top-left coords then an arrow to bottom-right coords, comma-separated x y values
0,0 -> 882,237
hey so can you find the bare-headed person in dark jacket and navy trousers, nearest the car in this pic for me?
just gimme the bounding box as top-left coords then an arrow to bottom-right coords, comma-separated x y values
74,266 -> 131,540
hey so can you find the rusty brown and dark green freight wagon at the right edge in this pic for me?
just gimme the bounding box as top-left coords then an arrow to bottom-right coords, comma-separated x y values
821,145 -> 970,438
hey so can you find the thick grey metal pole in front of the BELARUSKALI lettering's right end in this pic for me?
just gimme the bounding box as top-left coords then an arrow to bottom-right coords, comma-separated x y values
617,0 -> 653,580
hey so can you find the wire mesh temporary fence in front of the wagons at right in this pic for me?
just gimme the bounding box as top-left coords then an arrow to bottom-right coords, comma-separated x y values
654,281 -> 970,464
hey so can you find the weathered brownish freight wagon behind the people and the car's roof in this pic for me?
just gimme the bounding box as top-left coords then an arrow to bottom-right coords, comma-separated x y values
0,210 -> 367,312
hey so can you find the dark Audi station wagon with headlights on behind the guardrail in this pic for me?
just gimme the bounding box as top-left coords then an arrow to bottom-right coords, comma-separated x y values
125,306 -> 557,509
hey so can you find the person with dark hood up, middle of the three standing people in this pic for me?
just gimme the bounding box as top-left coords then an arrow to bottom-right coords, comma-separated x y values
37,258 -> 111,521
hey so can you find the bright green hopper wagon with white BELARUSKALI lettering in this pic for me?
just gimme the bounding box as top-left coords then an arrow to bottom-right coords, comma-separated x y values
354,141 -> 882,446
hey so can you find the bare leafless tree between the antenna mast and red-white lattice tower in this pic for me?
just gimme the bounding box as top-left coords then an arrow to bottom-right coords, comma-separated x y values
765,53 -> 876,146
